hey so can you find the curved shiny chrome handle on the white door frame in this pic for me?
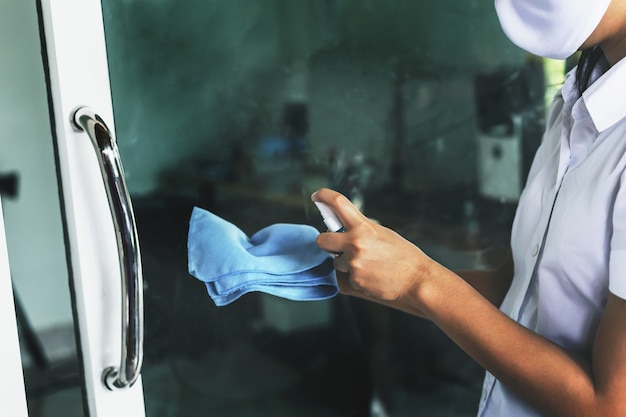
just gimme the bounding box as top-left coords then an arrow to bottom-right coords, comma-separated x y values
71,107 -> 143,391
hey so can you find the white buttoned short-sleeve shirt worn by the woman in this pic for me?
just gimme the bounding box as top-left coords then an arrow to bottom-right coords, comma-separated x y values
478,59 -> 626,417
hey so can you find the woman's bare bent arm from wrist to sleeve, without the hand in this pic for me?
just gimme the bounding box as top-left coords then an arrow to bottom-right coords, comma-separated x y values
424,267 -> 626,417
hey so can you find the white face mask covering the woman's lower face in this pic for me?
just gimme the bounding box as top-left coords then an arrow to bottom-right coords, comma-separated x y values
495,0 -> 611,59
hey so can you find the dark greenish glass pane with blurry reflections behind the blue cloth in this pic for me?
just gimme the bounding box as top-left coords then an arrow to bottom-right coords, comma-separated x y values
103,0 -> 545,417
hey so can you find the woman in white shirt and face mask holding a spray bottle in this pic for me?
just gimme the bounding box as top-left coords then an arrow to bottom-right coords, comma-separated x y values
312,0 -> 626,417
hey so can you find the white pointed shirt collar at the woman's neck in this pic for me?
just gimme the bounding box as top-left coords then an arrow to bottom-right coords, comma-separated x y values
583,55 -> 626,132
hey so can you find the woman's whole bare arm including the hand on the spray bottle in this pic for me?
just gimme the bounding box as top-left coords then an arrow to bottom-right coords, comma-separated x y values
313,189 -> 626,417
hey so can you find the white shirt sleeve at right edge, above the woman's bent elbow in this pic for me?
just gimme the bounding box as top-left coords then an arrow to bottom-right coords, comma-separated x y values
609,167 -> 626,299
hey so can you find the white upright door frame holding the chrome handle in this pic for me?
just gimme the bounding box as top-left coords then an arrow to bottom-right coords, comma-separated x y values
40,0 -> 145,417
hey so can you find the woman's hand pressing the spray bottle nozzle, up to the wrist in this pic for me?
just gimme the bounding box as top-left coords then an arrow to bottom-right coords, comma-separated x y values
311,188 -> 434,307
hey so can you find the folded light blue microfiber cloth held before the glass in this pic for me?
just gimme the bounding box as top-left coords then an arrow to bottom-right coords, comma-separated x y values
187,207 -> 339,306
